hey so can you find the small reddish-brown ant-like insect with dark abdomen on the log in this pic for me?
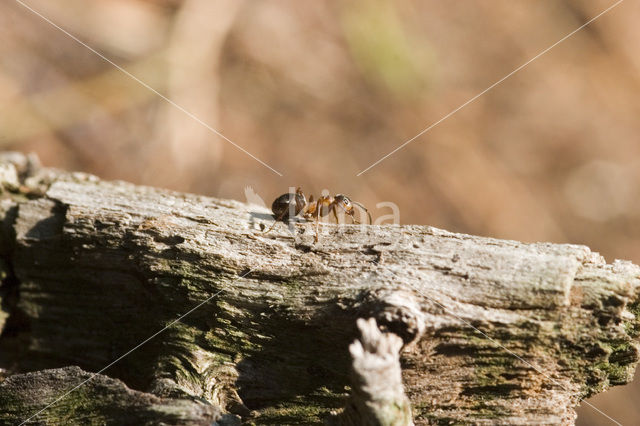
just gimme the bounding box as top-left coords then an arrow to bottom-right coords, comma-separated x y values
264,188 -> 371,242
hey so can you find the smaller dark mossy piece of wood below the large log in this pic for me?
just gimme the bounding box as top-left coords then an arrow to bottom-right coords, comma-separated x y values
0,367 -> 222,426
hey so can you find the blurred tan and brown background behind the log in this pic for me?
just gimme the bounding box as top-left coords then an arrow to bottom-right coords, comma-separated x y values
0,0 -> 640,425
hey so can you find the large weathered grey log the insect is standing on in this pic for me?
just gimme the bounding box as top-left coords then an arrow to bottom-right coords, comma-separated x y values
0,155 -> 640,424
